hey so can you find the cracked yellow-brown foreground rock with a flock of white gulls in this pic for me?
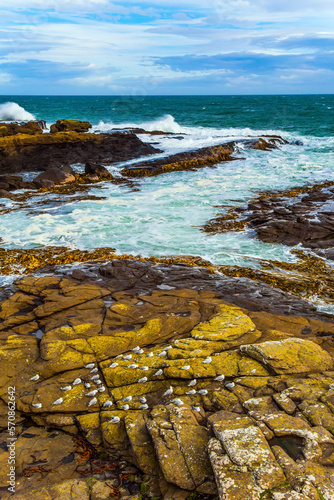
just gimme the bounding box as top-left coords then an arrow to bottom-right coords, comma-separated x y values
0,260 -> 334,500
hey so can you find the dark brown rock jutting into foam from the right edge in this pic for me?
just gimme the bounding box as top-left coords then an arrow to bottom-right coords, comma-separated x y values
203,181 -> 334,254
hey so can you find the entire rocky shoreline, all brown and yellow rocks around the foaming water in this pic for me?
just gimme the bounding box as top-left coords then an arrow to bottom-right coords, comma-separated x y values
0,120 -> 334,500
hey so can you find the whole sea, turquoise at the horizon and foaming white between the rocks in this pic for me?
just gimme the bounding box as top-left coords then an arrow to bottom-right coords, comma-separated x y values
0,95 -> 334,267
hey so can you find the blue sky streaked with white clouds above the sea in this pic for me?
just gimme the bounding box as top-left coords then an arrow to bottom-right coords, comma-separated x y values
0,0 -> 334,96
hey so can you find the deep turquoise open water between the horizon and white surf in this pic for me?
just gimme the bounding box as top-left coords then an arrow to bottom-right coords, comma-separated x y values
0,95 -> 334,137
